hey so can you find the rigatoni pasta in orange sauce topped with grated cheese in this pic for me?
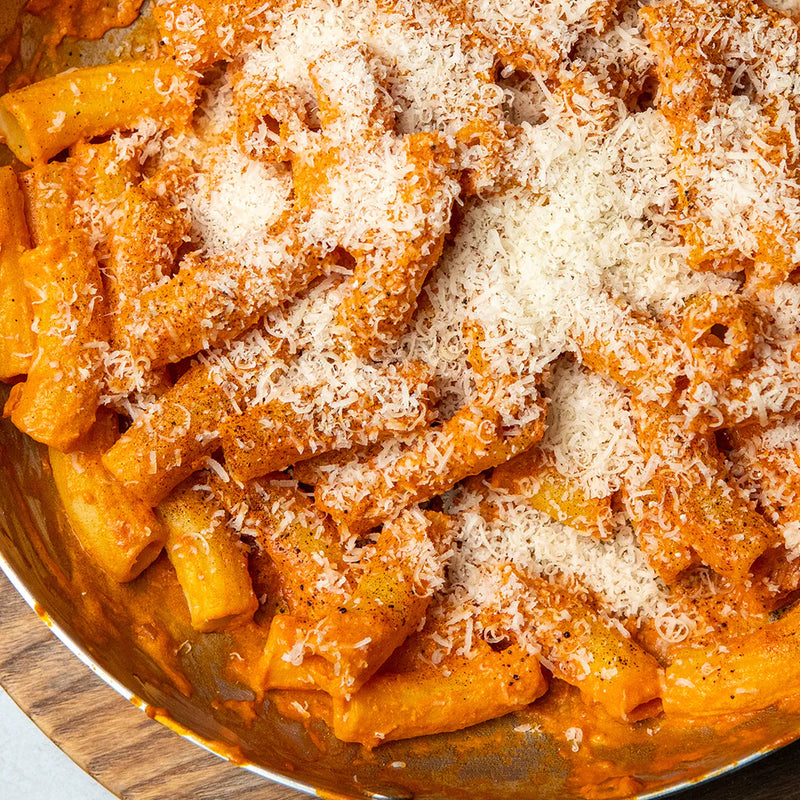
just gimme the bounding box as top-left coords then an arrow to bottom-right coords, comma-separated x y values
0,0 -> 800,796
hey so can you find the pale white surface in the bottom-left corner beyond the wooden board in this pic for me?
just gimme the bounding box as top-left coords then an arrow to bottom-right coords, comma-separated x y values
0,689 -> 114,800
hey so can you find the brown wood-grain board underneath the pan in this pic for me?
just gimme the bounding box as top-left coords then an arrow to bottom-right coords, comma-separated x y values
0,573 -> 800,800
